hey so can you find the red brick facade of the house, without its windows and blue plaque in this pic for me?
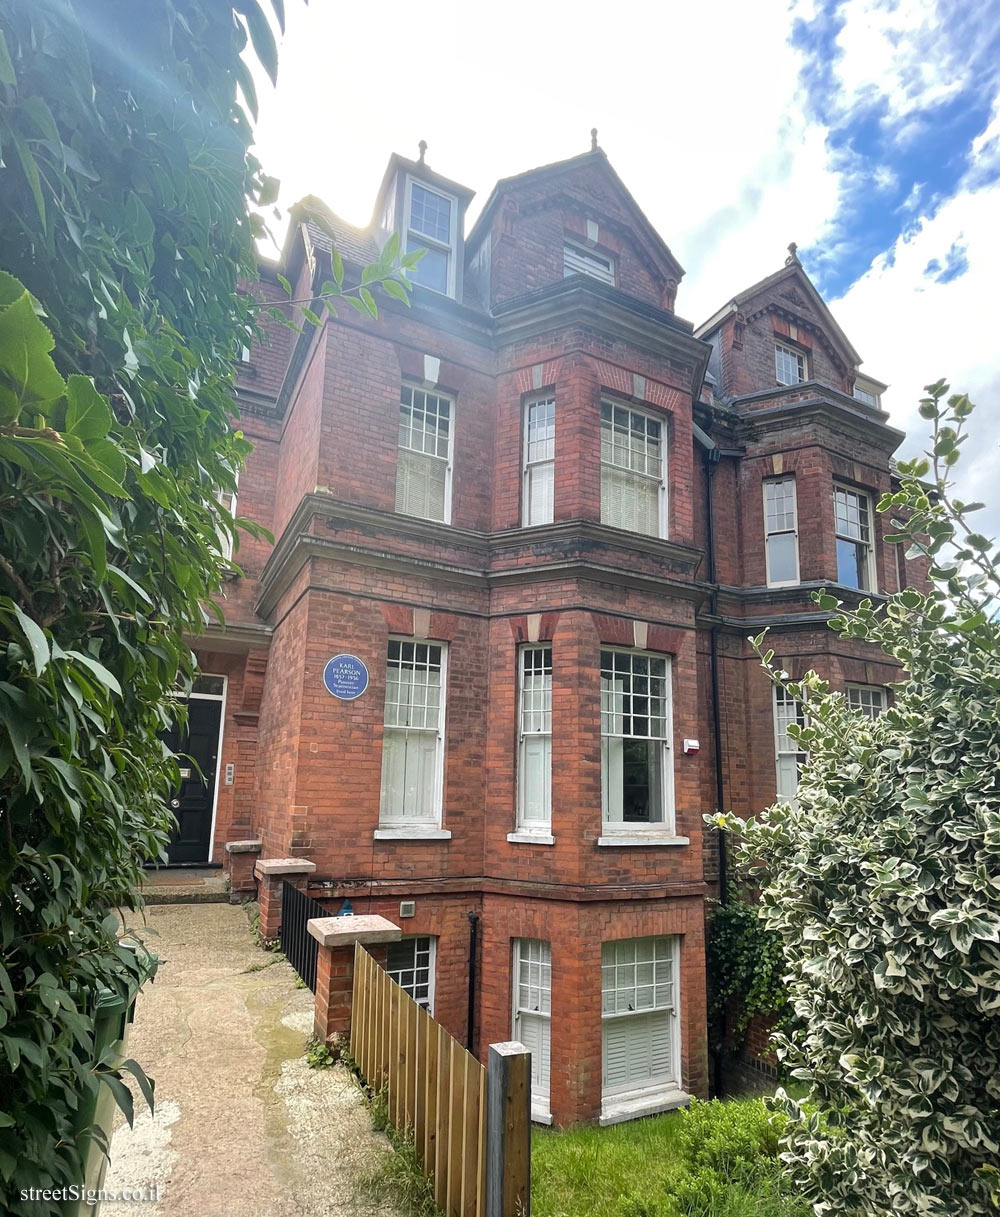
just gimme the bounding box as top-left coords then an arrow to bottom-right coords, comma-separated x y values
189,151 -> 934,1125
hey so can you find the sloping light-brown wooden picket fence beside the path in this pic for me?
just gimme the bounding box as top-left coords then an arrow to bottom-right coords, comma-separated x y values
350,942 -> 487,1217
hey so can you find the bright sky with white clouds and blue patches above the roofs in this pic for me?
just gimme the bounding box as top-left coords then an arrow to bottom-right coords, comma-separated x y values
258,0 -> 1000,529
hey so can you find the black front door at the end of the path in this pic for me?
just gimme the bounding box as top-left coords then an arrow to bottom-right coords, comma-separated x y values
165,697 -> 223,863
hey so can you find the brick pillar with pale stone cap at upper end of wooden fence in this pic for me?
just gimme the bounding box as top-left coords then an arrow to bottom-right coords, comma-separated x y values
307,915 -> 401,1047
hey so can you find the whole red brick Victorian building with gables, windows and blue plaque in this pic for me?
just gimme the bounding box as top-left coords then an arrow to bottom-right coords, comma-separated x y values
174,148 -> 929,1123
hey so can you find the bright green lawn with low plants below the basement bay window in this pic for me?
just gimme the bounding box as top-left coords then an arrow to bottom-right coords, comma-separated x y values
532,1099 -> 809,1217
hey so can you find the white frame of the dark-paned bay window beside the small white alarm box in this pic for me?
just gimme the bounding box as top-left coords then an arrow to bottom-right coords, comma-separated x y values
599,646 -> 671,842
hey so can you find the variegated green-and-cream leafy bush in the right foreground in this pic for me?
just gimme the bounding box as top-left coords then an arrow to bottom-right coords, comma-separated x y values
721,382 -> 1000,1217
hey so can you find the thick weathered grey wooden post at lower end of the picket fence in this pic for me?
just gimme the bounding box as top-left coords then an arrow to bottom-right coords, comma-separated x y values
485,1039 -> 532,1217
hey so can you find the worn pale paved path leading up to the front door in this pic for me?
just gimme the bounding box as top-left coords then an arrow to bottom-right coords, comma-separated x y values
101,904 -> 392,1217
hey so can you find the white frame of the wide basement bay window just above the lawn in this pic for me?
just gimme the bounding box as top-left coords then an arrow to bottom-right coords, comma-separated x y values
601,935 -> 684,1123
